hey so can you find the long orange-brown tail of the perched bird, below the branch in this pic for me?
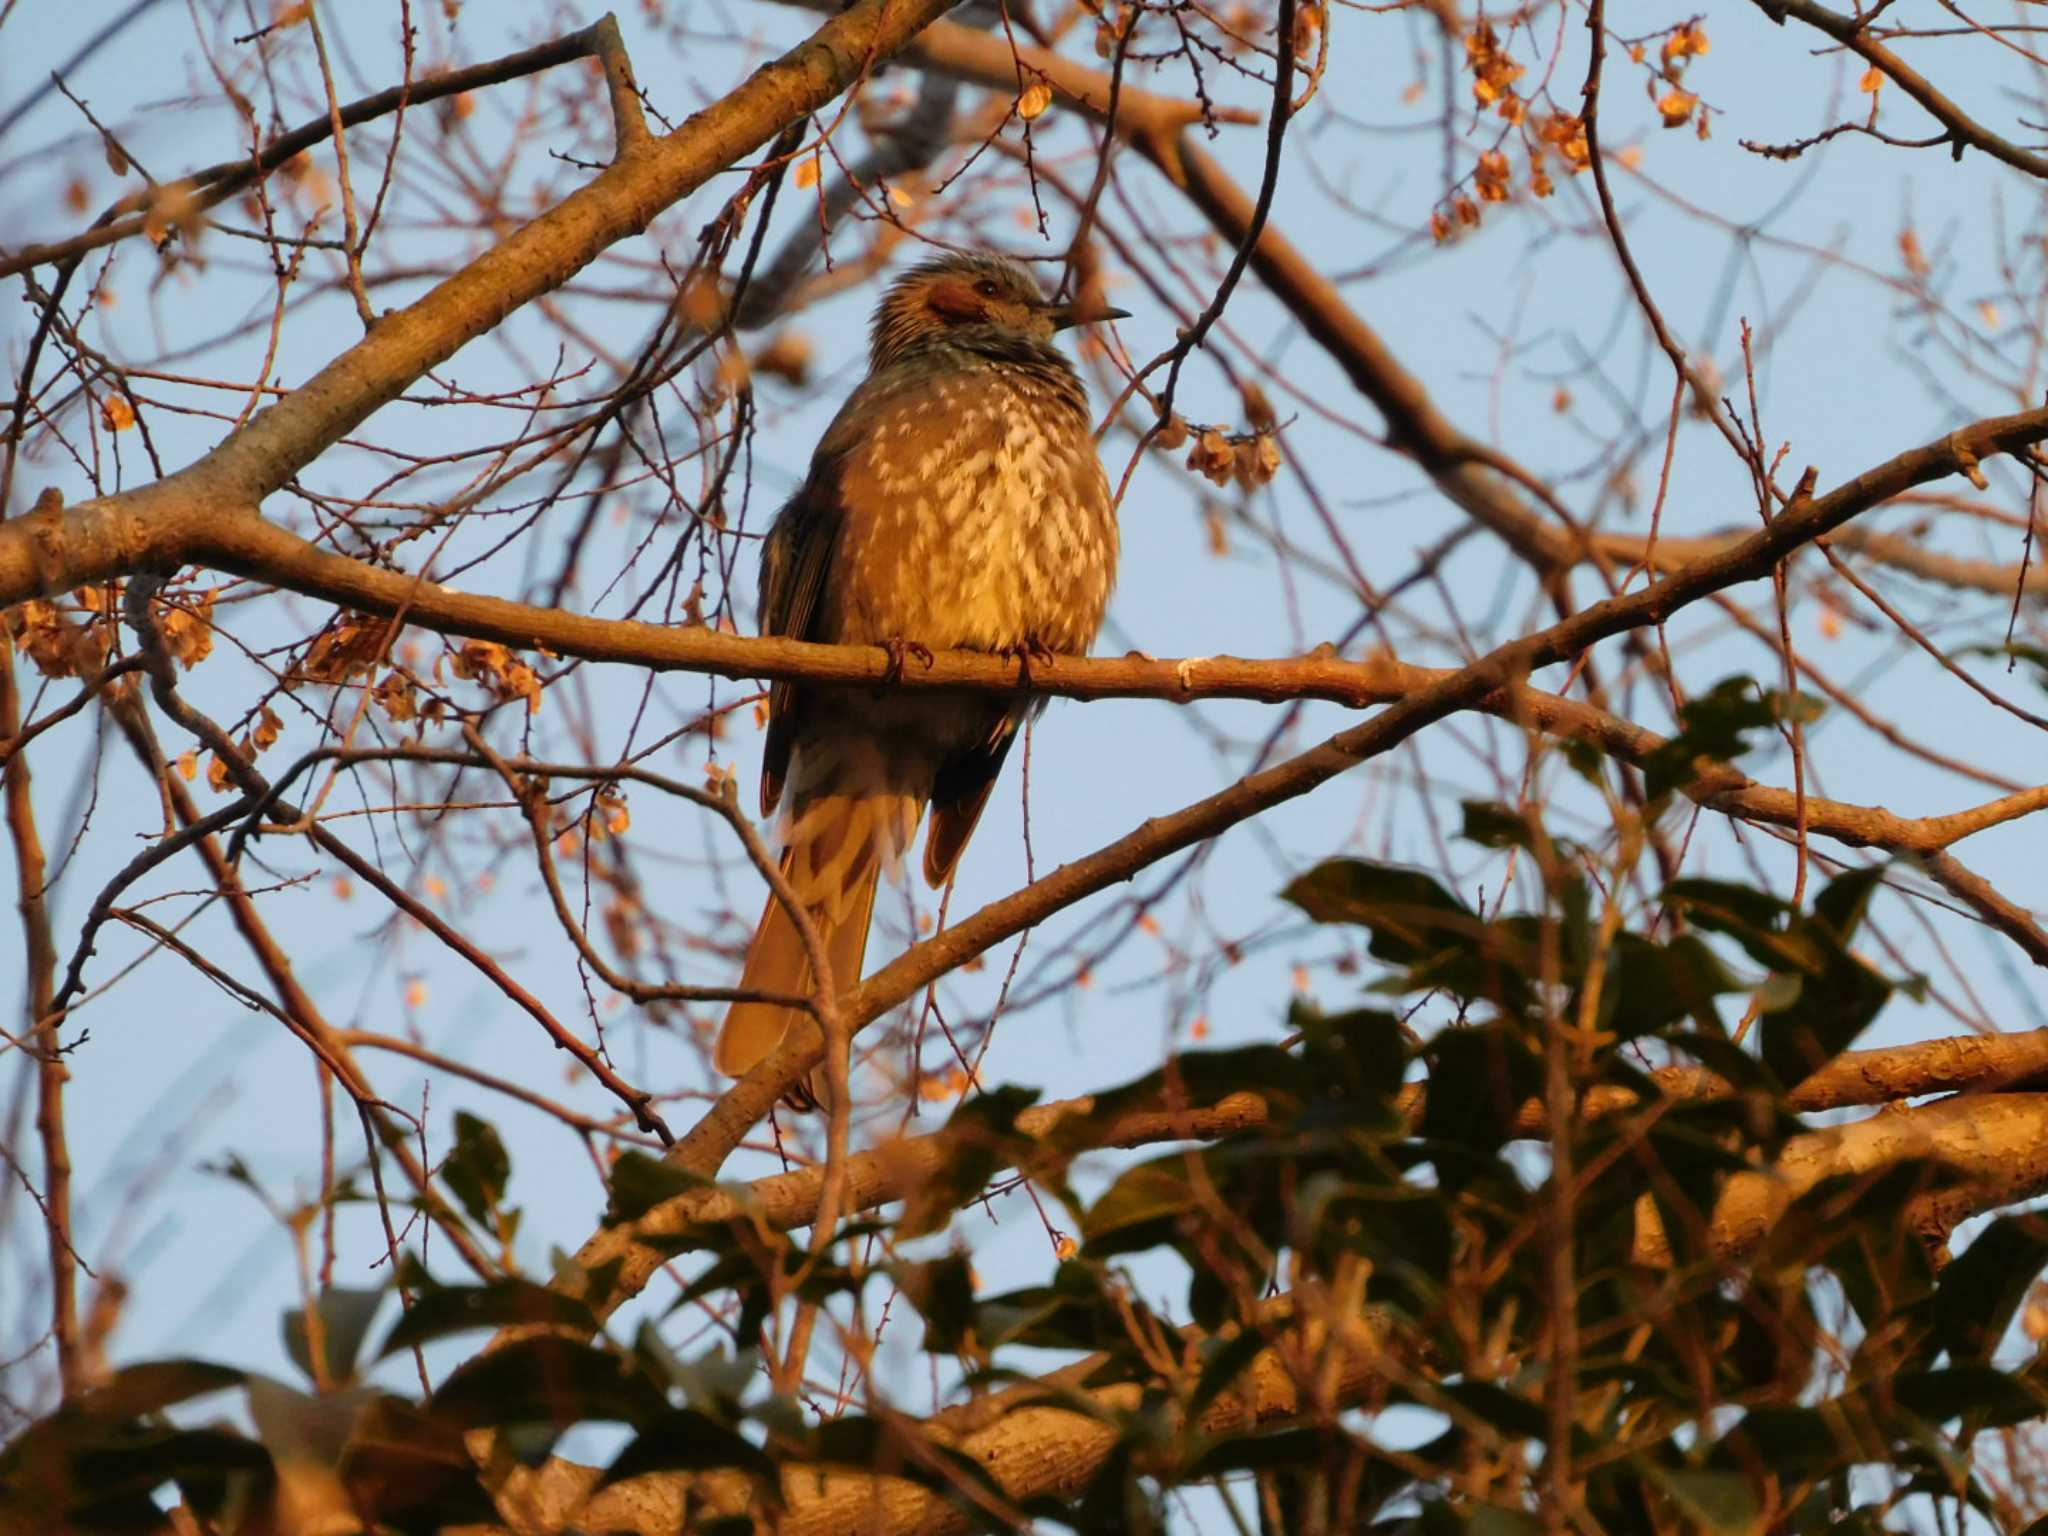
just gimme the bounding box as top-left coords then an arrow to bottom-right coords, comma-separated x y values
715,741 -> 930,1102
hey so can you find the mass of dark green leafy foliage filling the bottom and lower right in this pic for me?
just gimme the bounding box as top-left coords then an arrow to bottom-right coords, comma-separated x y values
0,811 -> 2048,1536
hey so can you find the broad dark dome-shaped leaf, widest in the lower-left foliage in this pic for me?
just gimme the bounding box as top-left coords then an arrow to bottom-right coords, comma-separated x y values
432,1335 -> 668,1430
